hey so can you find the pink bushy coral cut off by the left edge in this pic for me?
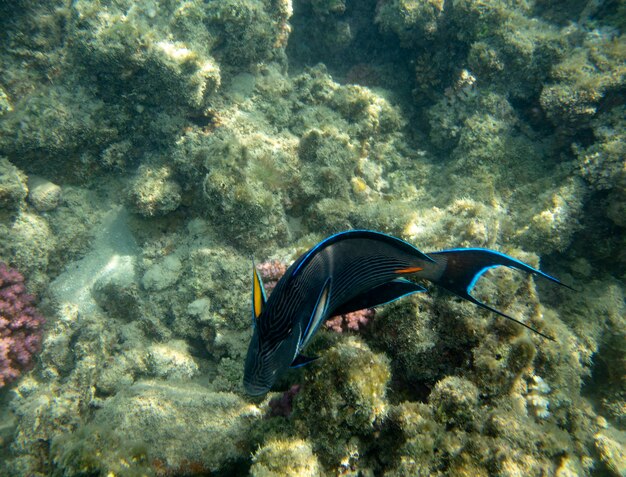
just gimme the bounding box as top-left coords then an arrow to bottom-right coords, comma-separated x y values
0,262 -> 44,388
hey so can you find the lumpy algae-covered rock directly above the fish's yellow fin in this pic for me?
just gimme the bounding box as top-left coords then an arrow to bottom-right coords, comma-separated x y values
174,126 -> 296,253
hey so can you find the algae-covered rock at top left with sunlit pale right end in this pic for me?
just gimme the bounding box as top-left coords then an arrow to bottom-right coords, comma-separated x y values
70,0 -> 221,108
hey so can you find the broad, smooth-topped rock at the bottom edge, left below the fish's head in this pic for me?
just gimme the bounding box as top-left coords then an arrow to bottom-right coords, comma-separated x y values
52,381 -> 262,475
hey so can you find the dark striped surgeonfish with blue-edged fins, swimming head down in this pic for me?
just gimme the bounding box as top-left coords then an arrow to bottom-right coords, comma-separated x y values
243,230 -> 569,396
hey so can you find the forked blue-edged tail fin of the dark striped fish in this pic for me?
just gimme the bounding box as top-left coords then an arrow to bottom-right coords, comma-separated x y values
428,248 -> 571,341
